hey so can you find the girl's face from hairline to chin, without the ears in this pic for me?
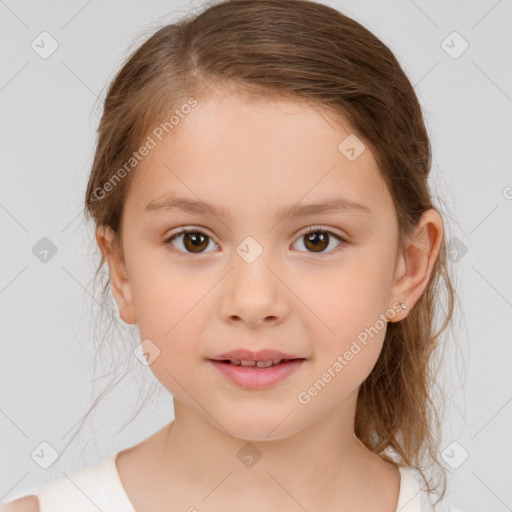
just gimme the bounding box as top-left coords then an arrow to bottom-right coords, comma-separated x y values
99,94 -> 412,440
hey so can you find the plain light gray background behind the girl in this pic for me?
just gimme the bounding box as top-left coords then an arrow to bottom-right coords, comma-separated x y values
0,0 -> 512,512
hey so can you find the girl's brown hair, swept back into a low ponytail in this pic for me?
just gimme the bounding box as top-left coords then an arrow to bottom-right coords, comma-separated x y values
77,0 -> 455,501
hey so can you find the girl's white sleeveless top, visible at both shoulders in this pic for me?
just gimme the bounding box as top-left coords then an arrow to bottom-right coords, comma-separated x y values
4,453 -> 458,512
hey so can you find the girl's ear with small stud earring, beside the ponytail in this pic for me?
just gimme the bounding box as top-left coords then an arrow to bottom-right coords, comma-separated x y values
388,208 -> 444,322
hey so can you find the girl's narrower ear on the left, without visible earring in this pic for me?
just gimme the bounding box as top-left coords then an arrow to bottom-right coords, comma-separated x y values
96,226 -> 137,324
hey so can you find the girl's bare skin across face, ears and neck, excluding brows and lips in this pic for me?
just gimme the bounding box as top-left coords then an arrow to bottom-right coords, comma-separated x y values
96,91 -> 443,512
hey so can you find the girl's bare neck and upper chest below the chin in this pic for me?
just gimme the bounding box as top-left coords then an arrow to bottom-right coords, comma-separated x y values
130,390 -> 399,512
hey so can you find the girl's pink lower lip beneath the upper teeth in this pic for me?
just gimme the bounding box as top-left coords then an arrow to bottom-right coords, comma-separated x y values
209,359 -> 305,389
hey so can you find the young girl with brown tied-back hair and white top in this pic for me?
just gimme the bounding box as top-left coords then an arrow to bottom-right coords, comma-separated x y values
1,0 -> 464,512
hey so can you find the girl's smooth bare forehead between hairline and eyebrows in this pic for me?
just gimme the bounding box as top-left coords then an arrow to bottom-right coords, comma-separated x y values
126,94 -> 390,219
